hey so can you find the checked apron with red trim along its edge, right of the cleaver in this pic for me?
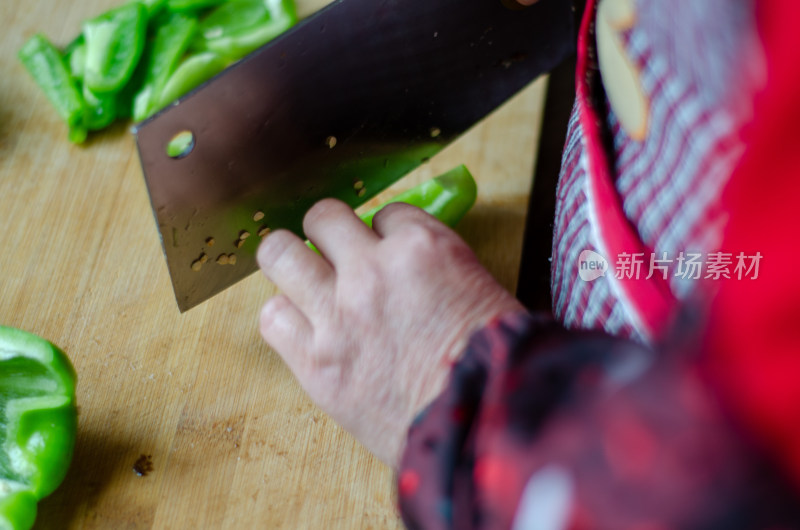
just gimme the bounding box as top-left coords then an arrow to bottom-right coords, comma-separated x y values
551,0 -> 757,341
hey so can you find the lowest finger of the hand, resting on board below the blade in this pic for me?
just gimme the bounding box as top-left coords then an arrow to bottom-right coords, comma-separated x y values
259,294 -> 314,373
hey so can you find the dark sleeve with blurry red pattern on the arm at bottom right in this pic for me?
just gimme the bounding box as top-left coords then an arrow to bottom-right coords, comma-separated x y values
398,314 -> 800,530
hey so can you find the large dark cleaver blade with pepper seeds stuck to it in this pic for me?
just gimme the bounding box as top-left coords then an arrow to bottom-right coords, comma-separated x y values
134,0 -> 576,311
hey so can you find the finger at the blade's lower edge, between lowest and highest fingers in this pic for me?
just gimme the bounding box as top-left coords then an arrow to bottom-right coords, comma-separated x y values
258,230 -> 335,316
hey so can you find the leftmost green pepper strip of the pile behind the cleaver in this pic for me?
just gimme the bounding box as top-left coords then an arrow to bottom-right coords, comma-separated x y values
19,34 -> 86,143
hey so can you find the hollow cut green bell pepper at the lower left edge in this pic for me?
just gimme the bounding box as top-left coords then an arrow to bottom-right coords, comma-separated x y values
0,326 -> 77,530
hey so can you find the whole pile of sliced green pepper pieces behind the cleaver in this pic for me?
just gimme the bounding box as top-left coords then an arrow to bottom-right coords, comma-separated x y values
19,0 -> 297,138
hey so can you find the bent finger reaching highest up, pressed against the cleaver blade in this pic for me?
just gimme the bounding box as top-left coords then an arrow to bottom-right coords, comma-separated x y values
303,199 -> 378,267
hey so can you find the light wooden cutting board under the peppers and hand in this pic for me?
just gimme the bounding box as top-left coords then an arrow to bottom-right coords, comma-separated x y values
0,0 -> 544,529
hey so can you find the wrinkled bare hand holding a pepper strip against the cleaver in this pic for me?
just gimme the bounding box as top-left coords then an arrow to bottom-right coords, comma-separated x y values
258,199 -> 523,466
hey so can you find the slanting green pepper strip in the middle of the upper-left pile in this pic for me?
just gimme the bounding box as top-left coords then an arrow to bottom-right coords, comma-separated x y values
133,13 -> 197,121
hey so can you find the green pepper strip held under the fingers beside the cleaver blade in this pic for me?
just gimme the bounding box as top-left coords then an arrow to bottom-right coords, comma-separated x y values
306,164 -> 478,252
